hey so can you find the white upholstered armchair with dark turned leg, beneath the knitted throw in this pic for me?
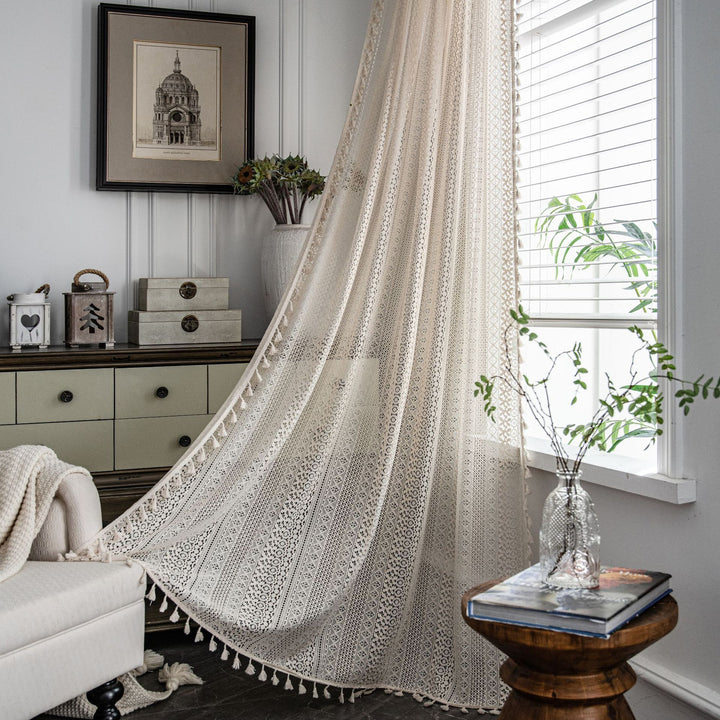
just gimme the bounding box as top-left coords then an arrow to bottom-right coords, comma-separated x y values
0,473 -> 145,720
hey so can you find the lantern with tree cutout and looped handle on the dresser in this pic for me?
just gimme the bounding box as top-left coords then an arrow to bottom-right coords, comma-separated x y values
63,268 -> 115,347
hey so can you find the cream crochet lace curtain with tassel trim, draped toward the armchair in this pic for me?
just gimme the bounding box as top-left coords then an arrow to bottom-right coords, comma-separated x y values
94,0 -> 527,708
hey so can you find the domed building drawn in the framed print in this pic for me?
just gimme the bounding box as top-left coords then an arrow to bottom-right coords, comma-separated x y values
153,50 -> 202,145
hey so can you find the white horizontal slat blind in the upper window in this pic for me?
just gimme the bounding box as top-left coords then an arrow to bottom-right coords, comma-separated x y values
516,0 -> 657,327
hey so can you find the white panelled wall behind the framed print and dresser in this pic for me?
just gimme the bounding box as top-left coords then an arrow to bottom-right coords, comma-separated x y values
0,0 -> 370,344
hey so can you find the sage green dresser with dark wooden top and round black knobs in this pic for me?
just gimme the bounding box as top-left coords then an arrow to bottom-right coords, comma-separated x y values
0,340 -> 257,523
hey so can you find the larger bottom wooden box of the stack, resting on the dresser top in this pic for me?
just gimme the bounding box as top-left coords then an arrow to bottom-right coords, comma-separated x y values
128,310 -> 242,345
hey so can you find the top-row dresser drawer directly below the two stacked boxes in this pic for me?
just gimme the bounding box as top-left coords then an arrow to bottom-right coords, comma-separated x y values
115,365 -> 207,418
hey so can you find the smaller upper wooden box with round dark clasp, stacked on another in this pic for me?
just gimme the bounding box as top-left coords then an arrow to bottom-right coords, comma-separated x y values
138,277 -> 230,311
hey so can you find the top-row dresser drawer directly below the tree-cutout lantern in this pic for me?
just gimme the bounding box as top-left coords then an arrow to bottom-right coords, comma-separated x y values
17,368 -> 113,423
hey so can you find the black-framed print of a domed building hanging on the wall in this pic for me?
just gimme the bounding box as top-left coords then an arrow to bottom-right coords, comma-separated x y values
96,3 -> 255,193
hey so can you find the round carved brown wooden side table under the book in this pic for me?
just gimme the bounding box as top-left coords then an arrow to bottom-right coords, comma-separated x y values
462,580 -> 678,720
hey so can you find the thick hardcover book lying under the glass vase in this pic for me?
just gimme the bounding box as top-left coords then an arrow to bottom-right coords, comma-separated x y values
467,564 -> 672,637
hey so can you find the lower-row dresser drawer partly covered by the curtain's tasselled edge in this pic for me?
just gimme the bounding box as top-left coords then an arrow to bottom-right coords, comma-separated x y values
115,415 -> 210,470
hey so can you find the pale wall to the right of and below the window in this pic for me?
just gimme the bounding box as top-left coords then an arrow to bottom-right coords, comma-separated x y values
530,0 -> 720,720
